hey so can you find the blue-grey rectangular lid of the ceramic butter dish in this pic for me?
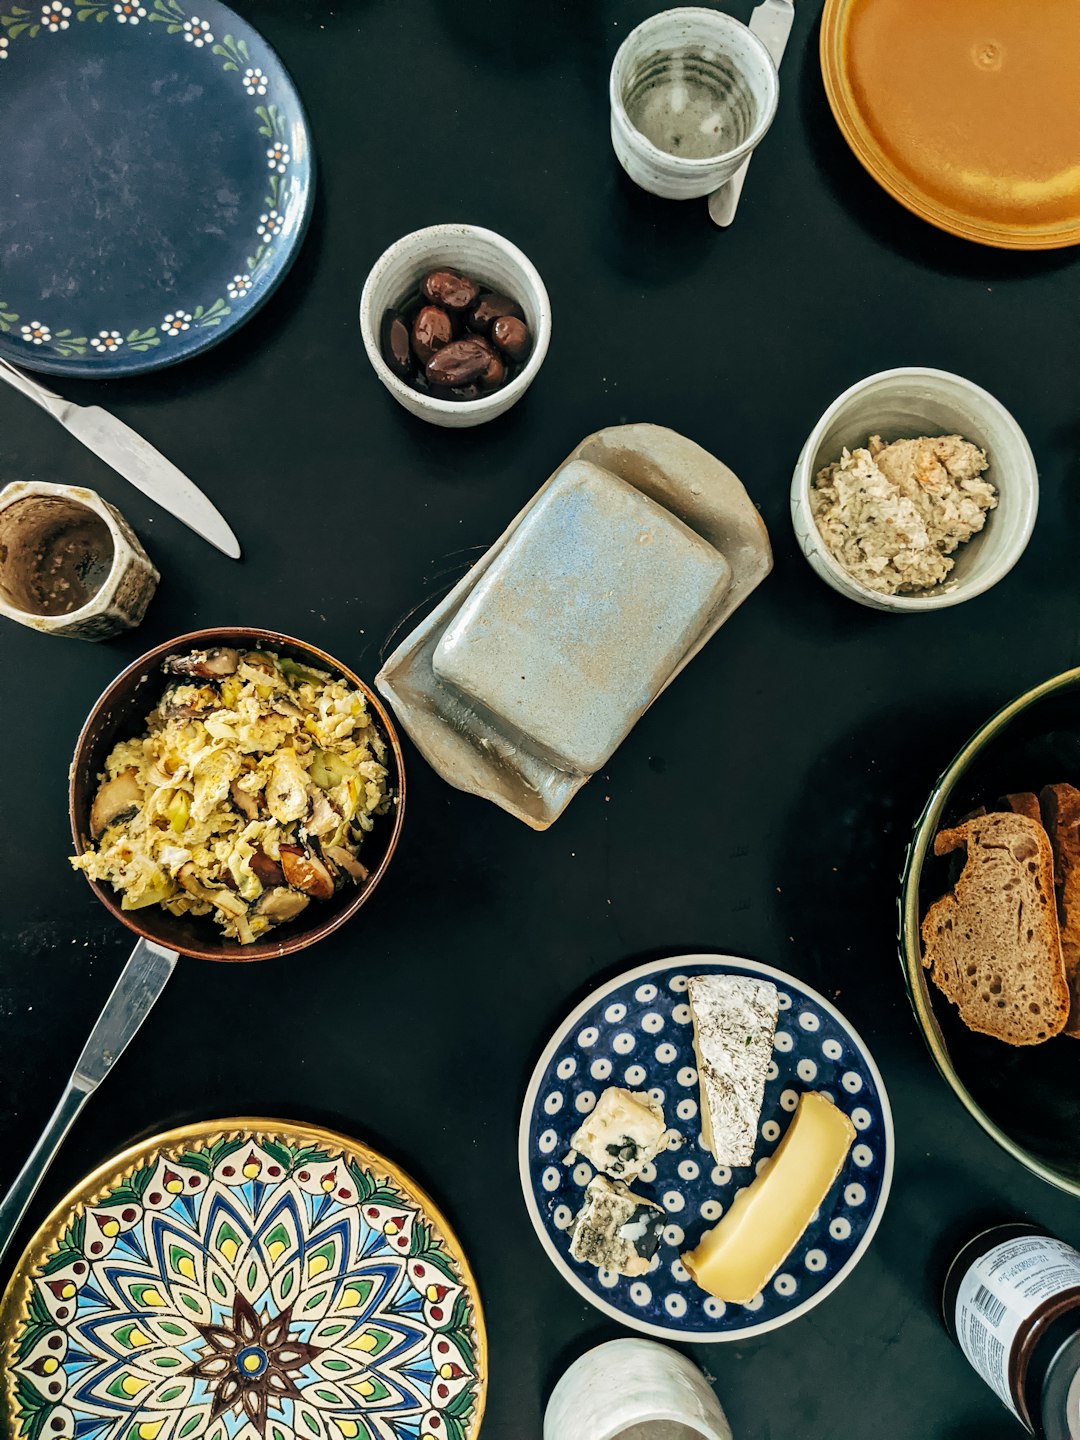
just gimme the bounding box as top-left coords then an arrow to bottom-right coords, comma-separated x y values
432,459 -> 732,775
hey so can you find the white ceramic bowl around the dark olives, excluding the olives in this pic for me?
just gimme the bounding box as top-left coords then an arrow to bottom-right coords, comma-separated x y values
360,225 -> 552,429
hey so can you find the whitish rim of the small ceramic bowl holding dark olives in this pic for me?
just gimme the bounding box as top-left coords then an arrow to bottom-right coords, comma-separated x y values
360,222 -> 552,419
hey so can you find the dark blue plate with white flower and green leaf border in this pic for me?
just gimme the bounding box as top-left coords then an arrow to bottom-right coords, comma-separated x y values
0,0 -> 314,376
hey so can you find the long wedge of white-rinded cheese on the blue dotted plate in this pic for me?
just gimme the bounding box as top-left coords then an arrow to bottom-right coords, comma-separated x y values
687,975 -> 779,1165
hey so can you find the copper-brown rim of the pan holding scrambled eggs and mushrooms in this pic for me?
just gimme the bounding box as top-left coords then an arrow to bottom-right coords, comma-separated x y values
68,625 -> 405,965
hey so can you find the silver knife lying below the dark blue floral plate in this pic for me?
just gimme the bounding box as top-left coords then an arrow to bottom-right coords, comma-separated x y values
0,359 -> 240,560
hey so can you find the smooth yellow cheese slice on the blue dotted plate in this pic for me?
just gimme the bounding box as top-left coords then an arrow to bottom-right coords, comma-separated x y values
683,1090 -> 855,1305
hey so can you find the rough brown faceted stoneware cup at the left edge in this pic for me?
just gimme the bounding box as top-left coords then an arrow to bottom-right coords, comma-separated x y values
0,481 -> 160,639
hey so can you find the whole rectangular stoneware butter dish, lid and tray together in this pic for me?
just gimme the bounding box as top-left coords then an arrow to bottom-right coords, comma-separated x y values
376,425 -> 772,829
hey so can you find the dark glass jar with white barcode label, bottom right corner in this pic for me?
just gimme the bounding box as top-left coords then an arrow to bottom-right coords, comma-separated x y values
943,1224 -> 1080,1440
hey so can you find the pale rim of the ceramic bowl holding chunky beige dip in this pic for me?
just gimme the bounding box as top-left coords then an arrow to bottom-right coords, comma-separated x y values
791,366 -> 1038,613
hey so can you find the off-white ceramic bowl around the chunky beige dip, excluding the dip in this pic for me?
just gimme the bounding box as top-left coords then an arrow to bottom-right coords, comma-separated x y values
791,369 -> 1038,612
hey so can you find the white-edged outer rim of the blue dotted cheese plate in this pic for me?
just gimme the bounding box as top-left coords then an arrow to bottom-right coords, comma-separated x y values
517,953 -> 896,1345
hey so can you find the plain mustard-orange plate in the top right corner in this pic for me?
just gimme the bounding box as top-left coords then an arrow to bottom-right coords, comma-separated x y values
821,0 -> 1080,251
